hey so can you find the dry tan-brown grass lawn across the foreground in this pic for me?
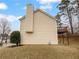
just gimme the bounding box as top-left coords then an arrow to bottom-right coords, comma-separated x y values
0,45 -> 79,59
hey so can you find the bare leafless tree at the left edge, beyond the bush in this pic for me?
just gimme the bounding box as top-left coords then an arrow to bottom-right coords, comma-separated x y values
0,18 -> 10,45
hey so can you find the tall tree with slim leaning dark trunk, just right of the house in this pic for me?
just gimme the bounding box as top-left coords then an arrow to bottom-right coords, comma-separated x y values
59,0 -> 73,34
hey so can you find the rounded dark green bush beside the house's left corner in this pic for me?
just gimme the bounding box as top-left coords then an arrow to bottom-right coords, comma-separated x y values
10,31 -> 21,46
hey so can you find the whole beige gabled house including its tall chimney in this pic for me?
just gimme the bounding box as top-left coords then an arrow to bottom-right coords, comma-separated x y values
20,5 -> 58,44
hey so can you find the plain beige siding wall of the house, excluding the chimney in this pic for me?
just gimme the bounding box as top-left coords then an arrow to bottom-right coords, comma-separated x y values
21,11 -> 58,44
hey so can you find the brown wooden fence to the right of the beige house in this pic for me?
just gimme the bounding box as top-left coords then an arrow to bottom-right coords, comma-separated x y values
58,34 -> 79,46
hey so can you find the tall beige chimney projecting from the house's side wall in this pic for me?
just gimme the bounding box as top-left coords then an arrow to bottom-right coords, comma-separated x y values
26,4 -> 34,33
